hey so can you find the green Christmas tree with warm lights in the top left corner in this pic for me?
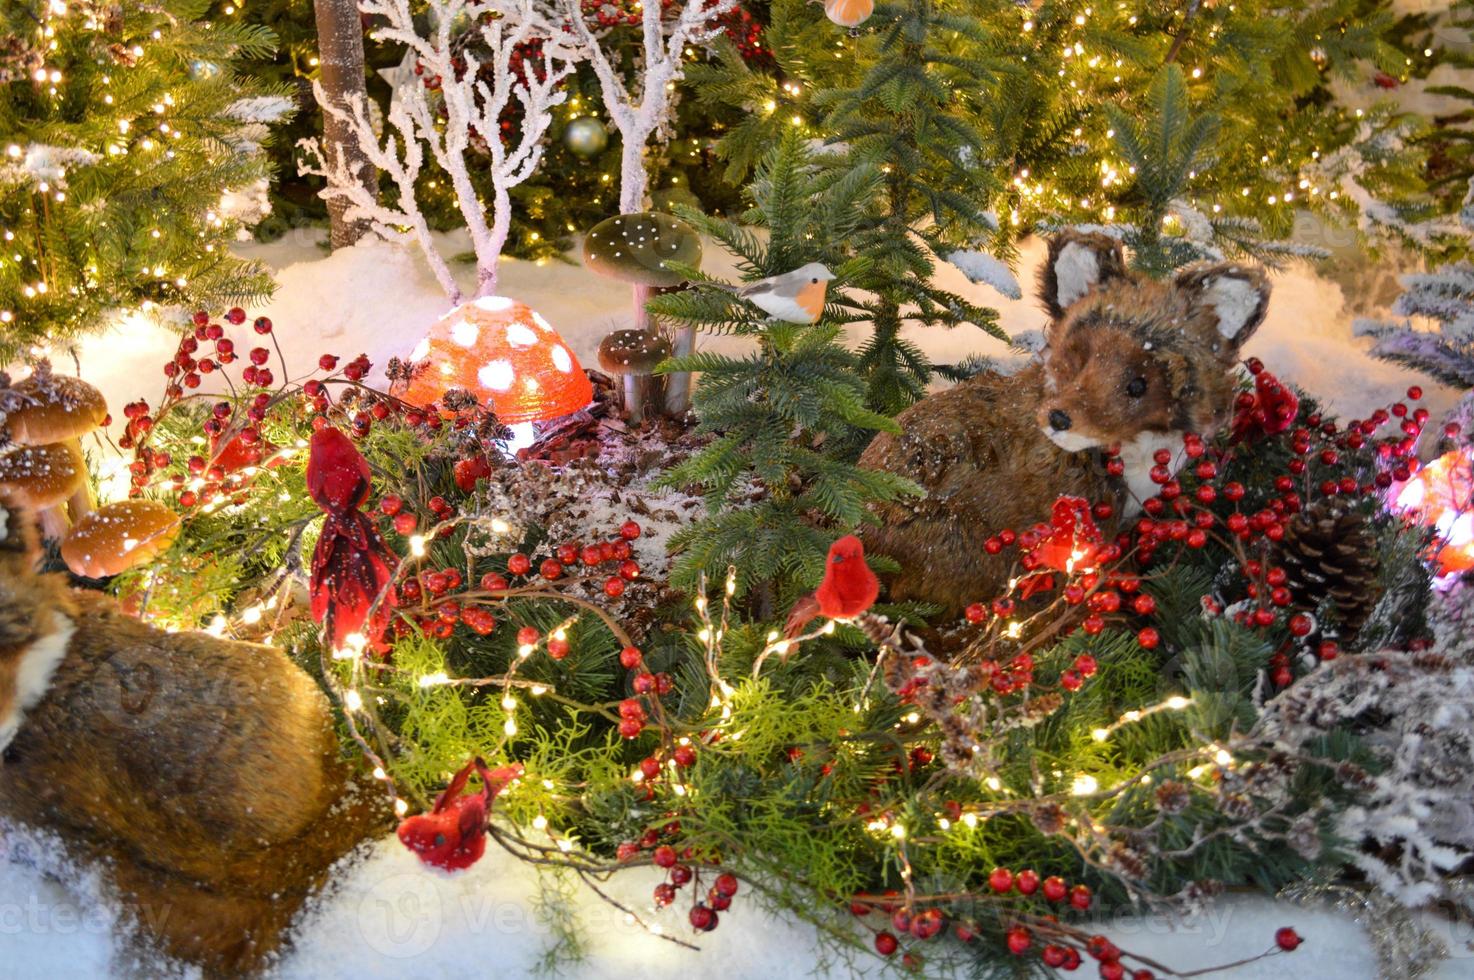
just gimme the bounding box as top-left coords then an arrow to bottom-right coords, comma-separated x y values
0,0 -> 292,363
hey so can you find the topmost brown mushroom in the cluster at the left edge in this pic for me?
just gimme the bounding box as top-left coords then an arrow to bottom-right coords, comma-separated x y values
0,361 -> 108,538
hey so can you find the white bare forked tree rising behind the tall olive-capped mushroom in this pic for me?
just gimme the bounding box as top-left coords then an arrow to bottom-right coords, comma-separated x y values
551,0 -> 737,214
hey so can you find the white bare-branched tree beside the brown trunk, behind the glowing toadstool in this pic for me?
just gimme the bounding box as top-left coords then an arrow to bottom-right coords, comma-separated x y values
299,0 -> 581,305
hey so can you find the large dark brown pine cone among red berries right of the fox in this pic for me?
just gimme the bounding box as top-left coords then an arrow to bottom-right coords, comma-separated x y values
1279,501 -> 1381,643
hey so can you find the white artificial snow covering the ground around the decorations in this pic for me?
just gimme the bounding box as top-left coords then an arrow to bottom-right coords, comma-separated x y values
0,234 -> 1474,980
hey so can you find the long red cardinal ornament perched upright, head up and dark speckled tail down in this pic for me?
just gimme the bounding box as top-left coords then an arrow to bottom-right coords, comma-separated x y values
307,426 -> 399,653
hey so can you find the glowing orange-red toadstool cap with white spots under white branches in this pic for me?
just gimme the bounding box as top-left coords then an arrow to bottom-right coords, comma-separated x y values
401,296 -> 594,426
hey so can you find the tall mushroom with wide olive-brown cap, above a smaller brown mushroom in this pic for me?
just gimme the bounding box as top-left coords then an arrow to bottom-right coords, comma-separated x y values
584,211 -> 702,414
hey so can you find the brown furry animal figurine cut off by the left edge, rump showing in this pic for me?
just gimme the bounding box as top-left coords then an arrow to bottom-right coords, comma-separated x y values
0,507 -> 388,976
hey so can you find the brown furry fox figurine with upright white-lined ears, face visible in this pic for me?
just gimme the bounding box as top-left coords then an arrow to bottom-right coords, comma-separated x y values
859,233 -> 1269,612
